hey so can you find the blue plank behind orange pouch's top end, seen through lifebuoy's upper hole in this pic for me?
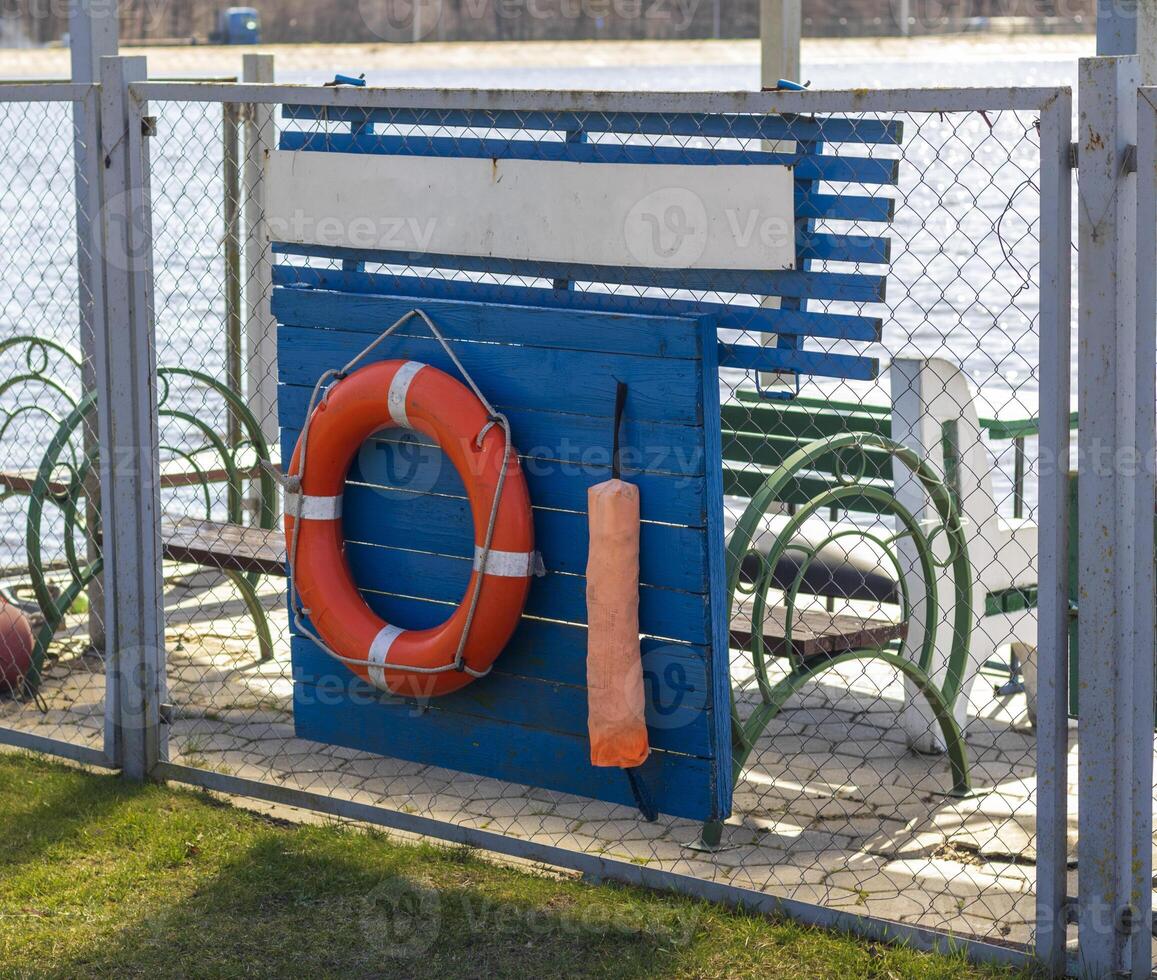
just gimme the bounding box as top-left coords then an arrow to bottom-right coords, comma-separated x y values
281,418 -> 707,528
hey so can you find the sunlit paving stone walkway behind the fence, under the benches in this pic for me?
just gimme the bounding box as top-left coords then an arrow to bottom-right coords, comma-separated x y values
0,571 -> 1077,942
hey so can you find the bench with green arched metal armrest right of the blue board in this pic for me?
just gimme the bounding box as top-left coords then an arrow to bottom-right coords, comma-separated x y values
702,393 -> 972,847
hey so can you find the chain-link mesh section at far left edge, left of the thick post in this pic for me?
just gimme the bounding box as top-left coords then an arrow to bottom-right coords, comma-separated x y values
0,93 -> 105,750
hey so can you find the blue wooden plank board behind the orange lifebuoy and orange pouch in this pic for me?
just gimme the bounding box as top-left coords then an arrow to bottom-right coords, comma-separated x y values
274,292 -> 730,818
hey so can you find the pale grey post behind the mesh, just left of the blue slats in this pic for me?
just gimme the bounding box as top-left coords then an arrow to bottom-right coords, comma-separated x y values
242,54 -> 281,445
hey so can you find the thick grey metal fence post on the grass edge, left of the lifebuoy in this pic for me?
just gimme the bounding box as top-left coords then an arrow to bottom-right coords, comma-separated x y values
95,58 -> 164,780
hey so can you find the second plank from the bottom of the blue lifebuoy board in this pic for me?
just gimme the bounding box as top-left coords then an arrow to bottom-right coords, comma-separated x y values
294,639 -> 712,759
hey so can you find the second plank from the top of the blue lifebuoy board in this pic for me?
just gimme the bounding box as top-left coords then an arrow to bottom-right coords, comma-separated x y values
278,326 -> 702,425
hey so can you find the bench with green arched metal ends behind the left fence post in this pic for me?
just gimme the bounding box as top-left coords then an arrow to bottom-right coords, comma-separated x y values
0,345 -> 282,694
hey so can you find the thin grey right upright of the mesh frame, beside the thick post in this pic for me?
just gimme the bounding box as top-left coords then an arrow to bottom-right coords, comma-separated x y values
1037,93 -> 1073,975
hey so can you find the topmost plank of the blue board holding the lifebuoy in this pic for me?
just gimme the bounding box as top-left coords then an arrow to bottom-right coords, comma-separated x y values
272,289 -> 699,360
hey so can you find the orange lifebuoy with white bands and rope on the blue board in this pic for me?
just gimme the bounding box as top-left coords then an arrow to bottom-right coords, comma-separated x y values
286,361 -> 535,697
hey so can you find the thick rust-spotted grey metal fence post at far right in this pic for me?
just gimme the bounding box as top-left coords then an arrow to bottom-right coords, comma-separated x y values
1073,56 -> 1157,977
